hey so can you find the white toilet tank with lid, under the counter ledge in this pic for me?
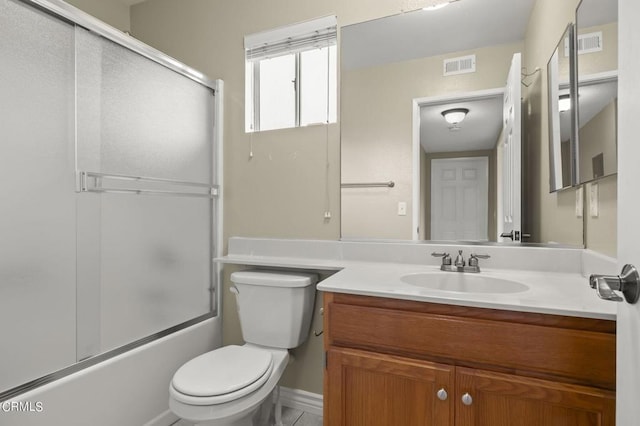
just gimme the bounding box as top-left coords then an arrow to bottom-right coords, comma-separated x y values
231,270 -> 318,349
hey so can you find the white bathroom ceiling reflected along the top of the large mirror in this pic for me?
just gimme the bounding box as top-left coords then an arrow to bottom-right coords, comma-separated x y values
340,0 -> 534,70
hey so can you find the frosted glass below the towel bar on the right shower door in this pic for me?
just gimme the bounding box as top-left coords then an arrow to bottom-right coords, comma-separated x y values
87,194 -> 211,351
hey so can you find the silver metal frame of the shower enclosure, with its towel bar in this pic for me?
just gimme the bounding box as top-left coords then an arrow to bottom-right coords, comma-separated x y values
0,0 -> 224,402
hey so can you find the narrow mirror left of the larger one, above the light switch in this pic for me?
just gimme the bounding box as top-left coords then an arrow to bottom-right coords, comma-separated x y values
547,24 -> 577,192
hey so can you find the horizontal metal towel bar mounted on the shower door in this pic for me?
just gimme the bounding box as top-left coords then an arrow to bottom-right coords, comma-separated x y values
77,171 -> 219,198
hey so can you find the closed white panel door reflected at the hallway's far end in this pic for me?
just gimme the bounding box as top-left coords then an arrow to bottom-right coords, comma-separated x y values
431,157 -> 489,241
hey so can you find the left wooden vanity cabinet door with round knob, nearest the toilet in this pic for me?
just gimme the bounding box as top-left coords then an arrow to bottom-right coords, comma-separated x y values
324,349 -> 454,426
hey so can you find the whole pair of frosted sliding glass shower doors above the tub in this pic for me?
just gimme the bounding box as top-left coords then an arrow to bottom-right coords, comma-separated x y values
0,0 -> 216,400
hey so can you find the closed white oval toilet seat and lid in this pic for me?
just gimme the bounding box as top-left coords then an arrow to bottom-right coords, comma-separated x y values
170,345 -> 273,405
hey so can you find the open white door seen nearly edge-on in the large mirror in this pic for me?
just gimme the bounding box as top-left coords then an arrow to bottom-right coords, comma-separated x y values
498,53 -> 522,241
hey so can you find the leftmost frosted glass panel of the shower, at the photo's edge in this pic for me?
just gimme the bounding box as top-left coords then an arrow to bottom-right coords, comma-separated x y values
0,0 -> 76,392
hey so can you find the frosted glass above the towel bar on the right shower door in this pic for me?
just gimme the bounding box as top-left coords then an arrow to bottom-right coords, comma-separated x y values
76,28 -> 213,183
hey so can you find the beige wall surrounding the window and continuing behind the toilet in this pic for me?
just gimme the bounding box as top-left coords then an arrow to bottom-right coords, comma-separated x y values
131,0 -> 422,393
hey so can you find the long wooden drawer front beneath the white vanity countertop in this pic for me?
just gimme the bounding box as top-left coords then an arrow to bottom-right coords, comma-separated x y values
325,296 -> 616,389
